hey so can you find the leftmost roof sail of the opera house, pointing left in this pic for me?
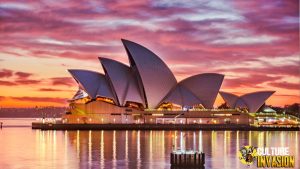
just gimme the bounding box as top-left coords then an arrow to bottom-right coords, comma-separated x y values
68,69 -> 116,101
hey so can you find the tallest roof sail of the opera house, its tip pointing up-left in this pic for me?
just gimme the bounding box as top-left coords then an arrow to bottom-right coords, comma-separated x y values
122,39 -> 177,108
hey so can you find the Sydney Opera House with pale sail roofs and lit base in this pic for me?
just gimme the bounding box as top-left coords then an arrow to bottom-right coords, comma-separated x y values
64,39 -> 274,124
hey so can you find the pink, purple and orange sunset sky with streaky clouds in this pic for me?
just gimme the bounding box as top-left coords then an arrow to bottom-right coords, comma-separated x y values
0,0 -> 300,107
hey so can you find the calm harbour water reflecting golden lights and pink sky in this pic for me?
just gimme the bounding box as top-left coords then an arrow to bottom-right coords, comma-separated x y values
0,121 -> 300,169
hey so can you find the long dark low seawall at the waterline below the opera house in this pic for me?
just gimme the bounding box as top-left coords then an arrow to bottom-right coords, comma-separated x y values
32,123 -> 300,131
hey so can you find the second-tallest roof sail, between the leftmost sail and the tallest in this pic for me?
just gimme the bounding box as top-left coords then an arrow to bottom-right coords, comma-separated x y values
99,58 -> 145,106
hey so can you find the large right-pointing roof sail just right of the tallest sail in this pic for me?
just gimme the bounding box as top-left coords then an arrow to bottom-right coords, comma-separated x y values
179,73 -> 224,108
